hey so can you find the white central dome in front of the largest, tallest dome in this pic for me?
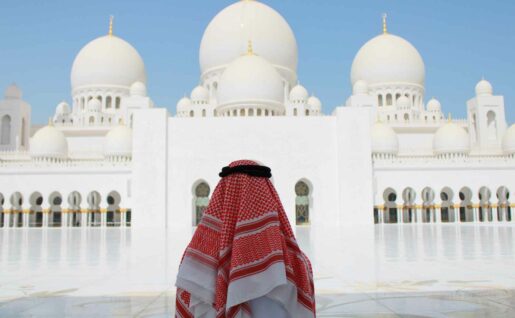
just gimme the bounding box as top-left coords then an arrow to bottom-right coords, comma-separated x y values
218,54 -> 284,106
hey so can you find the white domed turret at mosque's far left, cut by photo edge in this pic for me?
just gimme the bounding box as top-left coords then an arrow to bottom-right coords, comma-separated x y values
0,84 -> 31,151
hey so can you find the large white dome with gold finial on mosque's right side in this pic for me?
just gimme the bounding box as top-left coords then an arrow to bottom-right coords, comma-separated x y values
351,33 -> 425,86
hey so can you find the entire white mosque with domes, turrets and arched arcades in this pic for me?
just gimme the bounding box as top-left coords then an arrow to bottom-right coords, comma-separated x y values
0,1 -> 515,228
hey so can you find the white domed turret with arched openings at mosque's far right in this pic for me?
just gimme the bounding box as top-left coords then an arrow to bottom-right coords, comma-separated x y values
467,79 -> 506,153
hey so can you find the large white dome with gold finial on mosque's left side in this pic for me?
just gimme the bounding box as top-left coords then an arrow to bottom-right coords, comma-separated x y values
71,35 -> 147,91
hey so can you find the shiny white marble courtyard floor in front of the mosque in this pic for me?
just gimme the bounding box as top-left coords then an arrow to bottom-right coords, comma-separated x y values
0,224 -> 515,317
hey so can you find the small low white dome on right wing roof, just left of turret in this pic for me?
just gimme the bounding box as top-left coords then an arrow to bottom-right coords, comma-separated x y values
433,122 -> 470,155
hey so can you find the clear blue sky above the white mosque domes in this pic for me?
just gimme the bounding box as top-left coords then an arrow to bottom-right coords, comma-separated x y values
0,0 -> 515,123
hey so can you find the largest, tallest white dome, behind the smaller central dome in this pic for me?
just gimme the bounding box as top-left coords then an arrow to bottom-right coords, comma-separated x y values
200,1 -> 298,83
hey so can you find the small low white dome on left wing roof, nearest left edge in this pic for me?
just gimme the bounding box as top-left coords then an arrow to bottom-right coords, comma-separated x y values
30,126 -> 68,159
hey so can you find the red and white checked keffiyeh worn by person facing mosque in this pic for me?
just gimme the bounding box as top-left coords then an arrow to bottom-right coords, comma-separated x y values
176,160 -> 316,318
